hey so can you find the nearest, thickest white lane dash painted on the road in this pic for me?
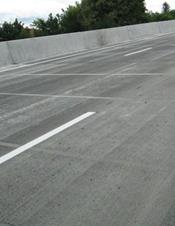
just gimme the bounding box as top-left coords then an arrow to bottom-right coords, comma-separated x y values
0,112 -> 95,164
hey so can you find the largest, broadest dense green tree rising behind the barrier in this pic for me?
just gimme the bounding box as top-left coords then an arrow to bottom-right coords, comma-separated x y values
82,0 -> 146,29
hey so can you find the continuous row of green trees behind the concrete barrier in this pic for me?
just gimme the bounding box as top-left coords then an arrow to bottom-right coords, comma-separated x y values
0,0 -> 175,41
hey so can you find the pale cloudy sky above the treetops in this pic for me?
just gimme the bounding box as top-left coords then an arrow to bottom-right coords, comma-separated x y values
0,0 -> 175,24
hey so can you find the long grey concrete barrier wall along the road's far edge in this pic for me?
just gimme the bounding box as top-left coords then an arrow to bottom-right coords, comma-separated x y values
0,20 -> 175,66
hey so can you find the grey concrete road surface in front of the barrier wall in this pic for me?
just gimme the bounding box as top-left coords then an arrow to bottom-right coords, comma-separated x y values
0,35 -> 175,226
